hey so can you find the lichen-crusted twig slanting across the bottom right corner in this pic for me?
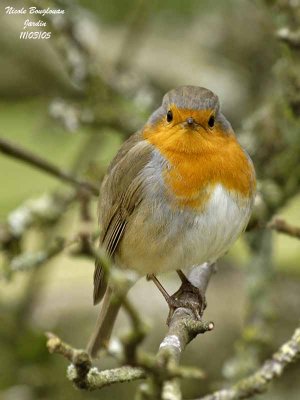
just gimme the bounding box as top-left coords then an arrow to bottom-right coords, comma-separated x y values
198,327 -> 300,400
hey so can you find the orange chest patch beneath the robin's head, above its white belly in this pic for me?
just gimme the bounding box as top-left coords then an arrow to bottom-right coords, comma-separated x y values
163,143 -> 255,210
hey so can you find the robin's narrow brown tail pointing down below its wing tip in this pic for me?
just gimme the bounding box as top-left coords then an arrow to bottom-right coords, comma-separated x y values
87,287 -> 121,357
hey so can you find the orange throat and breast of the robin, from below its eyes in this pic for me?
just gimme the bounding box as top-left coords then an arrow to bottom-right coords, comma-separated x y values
144,123 -> 255,209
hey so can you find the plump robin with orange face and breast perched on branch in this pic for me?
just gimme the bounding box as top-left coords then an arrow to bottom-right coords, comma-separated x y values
88,86 -> 256,356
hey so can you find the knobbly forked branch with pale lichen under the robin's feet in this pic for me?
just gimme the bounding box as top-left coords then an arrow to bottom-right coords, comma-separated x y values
47,264 -> 213,399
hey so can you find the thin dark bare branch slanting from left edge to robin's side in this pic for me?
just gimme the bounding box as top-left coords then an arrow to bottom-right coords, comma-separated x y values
0,138 -> 99,196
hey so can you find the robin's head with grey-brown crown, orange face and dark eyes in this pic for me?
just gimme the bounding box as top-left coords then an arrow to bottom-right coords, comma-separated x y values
144,86 -> 233,152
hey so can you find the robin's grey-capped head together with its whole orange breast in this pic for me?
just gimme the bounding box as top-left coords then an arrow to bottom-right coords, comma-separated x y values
142,86 -> 255,202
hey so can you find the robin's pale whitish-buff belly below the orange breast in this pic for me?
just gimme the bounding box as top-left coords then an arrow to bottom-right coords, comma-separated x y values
116,185 -> 252,275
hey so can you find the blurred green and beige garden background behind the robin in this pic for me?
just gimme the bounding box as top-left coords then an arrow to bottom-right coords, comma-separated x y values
0,0 -> 300,400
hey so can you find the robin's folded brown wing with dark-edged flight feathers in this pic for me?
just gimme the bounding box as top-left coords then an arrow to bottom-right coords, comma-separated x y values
94,133 -> 153,304
